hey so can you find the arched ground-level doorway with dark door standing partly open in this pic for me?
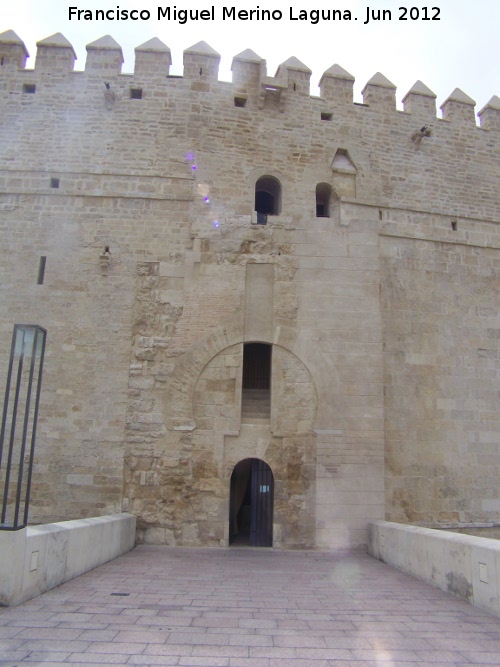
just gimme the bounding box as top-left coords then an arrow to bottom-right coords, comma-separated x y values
229,459 -> 274,547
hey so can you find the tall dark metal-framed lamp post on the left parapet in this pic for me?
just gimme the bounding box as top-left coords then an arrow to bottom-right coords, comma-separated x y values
0,324 -> 47,530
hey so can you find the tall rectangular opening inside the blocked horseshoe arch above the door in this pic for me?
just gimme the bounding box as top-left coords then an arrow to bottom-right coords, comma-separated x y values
241,343 -> 272,423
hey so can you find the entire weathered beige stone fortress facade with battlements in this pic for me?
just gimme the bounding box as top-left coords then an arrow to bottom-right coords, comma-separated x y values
0,31 -> 500,548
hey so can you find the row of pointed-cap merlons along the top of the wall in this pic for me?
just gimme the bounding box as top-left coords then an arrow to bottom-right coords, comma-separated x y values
0,30 -> 500,132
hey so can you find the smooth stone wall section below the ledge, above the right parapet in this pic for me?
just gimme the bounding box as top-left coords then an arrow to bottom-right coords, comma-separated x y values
381,219 -> 500,525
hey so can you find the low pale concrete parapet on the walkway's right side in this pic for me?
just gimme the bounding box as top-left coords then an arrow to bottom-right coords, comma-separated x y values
368,521 -> 500,616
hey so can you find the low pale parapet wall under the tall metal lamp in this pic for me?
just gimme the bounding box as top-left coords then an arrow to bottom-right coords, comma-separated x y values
0,514 -> 136,606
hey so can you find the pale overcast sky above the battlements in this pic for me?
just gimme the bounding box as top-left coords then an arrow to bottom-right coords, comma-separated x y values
0,0 -> 500,114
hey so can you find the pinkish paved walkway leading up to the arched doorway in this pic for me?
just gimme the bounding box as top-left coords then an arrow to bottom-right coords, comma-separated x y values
0,546 -> 500,667
